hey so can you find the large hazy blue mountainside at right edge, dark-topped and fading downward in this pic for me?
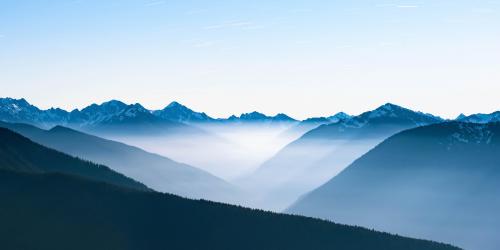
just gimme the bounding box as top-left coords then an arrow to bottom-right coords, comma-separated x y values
288,122 -> 500,250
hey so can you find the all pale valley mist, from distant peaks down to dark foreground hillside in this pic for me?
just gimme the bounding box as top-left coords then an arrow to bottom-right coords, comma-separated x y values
94,123 -> 382,212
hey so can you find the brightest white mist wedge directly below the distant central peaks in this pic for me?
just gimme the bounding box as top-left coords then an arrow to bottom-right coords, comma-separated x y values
101,124 -> 293,181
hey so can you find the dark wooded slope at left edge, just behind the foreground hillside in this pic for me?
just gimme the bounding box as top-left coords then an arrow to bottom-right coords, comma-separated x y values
0,128 -> 148,190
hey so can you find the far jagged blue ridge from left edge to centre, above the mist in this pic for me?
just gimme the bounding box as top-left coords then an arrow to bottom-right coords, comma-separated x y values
0,98 -> 296,130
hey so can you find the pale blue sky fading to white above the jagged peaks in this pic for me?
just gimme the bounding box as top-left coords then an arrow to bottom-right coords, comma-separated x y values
0,0 -> 500,118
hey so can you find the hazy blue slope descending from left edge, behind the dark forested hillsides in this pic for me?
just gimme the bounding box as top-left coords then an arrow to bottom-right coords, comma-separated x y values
0,122 -> 241,202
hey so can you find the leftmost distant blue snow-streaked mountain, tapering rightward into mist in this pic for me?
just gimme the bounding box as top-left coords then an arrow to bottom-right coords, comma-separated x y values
0,98 -> 206,136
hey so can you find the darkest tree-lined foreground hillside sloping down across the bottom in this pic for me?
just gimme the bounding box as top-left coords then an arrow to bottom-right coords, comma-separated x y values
0,170 -> 457,250
